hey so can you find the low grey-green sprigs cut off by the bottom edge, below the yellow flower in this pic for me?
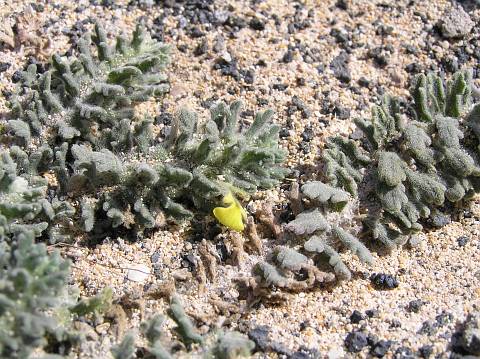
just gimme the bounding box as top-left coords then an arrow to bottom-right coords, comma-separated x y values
111,297 -> 255,359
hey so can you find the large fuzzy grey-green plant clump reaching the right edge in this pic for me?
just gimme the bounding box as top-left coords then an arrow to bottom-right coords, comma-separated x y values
323,71 -> 480,248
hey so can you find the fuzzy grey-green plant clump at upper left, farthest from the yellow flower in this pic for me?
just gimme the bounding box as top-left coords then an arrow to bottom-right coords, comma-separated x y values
8,23 -> 169,150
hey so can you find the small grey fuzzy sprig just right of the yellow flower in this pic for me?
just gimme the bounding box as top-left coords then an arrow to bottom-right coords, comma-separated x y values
253,181 -> 372,292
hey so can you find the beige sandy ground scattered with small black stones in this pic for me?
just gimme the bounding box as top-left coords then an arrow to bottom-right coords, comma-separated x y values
0,0 -> 480,358
